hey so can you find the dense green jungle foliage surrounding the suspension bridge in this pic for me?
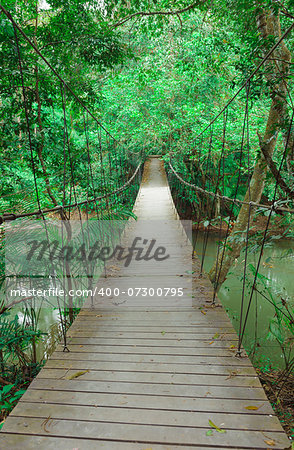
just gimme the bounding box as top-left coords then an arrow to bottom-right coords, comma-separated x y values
0,0 -> 294,434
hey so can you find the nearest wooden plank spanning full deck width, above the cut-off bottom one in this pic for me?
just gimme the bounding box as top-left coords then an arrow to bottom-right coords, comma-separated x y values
1,416 -> 288,449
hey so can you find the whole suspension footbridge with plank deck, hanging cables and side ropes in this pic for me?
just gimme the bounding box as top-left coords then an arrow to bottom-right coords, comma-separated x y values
0,5 -> 294,450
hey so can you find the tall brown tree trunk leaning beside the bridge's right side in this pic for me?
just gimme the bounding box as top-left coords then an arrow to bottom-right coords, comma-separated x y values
209,11 -> 291,290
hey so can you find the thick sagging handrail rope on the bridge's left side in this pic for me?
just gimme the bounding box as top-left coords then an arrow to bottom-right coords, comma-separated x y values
0,162 -> 142,225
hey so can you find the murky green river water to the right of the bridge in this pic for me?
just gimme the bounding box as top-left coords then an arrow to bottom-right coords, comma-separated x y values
196,233 -> 294,368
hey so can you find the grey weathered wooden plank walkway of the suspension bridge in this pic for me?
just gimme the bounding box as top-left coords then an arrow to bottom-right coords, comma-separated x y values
0,158 -> 290,450
